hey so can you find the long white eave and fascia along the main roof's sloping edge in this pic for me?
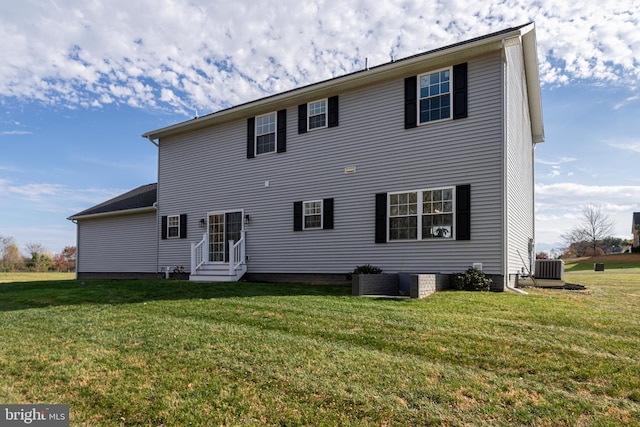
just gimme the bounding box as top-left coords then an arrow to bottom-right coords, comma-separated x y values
142,24 -> 537,140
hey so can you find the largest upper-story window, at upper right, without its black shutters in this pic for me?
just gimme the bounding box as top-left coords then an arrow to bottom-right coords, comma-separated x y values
418,68 -> 452,123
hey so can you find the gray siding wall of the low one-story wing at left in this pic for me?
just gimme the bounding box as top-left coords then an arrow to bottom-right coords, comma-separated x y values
77,212 -> 157,273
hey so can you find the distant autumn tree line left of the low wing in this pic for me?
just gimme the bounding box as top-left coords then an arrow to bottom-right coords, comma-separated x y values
0,236 -> 76,272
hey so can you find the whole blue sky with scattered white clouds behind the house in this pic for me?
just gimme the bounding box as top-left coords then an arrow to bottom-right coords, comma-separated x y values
0,0 -> 640,252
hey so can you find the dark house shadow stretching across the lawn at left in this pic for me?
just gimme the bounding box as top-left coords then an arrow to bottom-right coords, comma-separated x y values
0,279 -> 351,311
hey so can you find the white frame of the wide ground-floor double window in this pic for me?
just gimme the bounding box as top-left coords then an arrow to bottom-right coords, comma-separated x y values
387,186 -> 456,242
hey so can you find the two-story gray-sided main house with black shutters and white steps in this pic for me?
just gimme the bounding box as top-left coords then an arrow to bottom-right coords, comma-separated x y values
72,24 -> 544,289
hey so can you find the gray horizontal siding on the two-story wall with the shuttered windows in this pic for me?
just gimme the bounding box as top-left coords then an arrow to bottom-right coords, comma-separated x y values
158,52 -> 504,274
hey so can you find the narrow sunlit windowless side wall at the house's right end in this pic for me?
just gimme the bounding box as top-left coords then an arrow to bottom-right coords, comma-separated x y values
505,44 -> 534,274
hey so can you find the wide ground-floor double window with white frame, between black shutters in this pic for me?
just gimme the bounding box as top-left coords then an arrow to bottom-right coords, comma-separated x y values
389,187 -> 454,241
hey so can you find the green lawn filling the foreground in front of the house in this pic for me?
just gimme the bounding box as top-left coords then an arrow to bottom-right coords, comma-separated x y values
0,271 -> 640,426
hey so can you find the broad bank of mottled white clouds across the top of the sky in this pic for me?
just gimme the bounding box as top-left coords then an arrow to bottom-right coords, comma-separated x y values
0,0 -> 640,114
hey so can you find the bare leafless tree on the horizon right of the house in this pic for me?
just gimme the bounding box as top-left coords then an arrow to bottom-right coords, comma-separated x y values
561,204 -> 613,255
